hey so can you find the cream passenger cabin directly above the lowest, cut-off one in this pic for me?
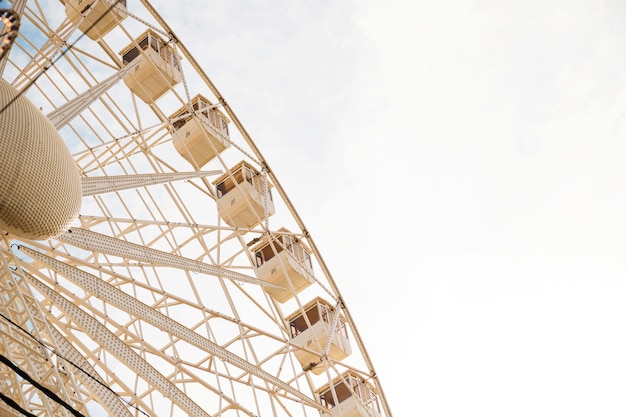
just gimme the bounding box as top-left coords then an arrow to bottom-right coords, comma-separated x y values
287,297 -> 352,375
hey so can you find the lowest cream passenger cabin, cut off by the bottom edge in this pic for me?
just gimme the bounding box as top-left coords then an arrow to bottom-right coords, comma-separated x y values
317,371 -> 381,417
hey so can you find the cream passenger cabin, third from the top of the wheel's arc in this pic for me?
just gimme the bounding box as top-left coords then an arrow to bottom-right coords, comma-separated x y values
170,95 -> 230,169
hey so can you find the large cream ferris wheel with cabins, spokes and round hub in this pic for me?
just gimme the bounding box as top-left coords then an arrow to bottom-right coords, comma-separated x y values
0,0 -> 391,417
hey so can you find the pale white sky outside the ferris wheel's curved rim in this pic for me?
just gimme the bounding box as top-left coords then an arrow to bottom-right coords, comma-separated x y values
153,0 -> 626,417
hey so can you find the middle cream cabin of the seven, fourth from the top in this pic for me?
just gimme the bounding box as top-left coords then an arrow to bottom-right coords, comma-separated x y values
213,161 -> 275,228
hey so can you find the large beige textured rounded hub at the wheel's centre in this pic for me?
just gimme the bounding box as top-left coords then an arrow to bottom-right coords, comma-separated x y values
0,78 -> 82,240
